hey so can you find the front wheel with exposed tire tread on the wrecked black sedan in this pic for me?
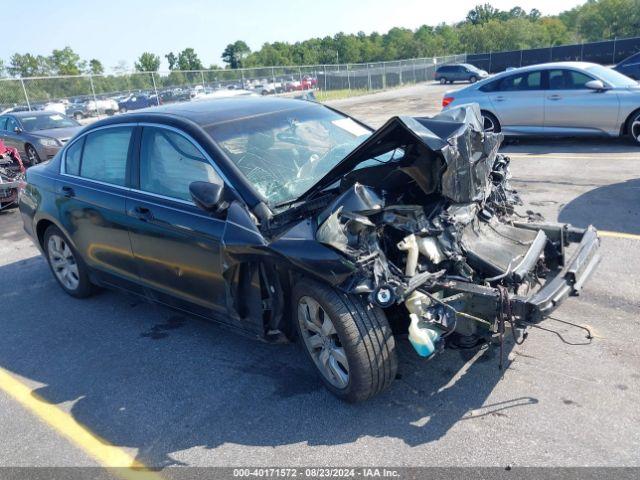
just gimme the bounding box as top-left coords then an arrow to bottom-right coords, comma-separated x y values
293,280 -> 398,402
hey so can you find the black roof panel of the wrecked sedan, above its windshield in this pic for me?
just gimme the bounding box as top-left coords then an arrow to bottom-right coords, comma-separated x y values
91,95 -> 320,127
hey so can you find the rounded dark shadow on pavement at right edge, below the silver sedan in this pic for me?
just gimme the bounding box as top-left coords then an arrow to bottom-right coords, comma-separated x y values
558,179 -> 640,235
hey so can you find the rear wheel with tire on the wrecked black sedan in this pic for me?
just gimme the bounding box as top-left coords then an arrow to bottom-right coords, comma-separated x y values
43,225 -> 93,298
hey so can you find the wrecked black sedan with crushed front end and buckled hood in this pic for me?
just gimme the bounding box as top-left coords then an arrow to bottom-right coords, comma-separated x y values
20,97 -> 599,401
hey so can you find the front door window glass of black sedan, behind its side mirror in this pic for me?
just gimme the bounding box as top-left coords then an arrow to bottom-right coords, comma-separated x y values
140,127 -> 222,201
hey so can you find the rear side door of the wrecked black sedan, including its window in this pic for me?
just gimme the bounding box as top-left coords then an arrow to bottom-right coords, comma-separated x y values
57,125 -> 138,287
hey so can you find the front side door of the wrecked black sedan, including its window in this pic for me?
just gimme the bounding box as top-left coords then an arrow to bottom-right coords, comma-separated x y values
127,126 -> 226,316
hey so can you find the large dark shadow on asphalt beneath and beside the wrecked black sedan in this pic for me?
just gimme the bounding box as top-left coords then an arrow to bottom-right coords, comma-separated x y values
0,257 -> 537,468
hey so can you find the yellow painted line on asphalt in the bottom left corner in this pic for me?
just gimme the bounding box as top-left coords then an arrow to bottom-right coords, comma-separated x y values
0,367 -> 162,480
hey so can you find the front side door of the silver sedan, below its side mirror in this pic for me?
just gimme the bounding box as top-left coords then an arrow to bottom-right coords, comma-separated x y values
544,68 -> 620,135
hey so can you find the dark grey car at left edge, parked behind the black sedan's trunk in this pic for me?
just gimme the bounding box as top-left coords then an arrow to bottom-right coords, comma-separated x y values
0,111 -> 82,165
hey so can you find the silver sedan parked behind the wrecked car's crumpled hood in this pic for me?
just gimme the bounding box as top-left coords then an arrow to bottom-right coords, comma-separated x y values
442,62 -> 640,144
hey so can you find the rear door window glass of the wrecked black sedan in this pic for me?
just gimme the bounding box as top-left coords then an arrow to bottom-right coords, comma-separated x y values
80,127 -> 133,185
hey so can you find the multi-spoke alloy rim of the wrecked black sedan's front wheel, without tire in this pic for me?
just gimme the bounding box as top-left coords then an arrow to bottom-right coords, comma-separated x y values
298,296 -> 349,389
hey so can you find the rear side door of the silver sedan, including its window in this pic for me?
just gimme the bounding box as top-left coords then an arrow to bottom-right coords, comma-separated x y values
489,70 -> 545,134
